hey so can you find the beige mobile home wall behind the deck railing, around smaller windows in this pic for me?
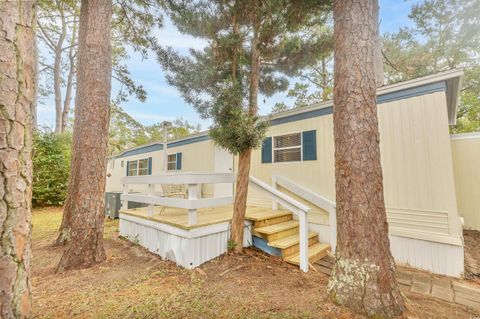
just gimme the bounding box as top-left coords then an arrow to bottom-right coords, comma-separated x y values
106,140 -> 214,197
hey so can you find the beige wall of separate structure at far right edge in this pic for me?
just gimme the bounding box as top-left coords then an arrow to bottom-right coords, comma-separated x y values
451,133 -> 480,230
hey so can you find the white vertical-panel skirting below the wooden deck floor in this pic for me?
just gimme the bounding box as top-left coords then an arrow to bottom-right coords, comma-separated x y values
120,214 -> 252,269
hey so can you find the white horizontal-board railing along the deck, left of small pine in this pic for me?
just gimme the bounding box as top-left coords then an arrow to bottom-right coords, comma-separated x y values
121,172 -> 236,225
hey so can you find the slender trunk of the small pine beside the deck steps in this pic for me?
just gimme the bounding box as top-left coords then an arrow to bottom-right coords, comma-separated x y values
230,3 -> 260,253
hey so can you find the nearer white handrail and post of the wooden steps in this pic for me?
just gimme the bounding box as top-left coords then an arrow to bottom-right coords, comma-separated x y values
249,176 -> 310,272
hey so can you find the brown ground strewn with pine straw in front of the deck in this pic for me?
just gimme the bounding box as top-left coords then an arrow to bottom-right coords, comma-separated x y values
32,208 -> 479,319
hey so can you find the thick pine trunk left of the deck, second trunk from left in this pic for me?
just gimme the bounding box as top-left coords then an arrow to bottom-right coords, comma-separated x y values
58,0 -> 112,271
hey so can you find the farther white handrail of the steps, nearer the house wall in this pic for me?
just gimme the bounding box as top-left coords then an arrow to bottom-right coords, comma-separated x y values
272,175 -> 337,252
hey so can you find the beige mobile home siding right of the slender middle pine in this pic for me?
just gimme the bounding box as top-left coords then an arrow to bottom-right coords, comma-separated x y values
246,92 -> 461,245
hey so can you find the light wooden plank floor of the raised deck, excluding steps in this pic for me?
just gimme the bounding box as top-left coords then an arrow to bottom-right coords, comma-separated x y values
120,205 -> 286,230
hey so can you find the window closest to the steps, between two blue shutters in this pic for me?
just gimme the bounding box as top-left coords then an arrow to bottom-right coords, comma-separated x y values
273,133 -> 302,163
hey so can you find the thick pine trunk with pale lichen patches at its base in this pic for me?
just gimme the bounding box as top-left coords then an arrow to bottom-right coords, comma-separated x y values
328,0 -> 404,318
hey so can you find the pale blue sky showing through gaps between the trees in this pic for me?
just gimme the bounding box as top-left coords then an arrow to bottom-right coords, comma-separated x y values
38,0 -> 420,129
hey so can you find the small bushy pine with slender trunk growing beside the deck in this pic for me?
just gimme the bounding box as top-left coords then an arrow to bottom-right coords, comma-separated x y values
159,0 -> 330,252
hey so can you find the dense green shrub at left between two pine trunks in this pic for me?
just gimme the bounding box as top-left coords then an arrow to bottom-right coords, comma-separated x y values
32,129 -> 72,206
